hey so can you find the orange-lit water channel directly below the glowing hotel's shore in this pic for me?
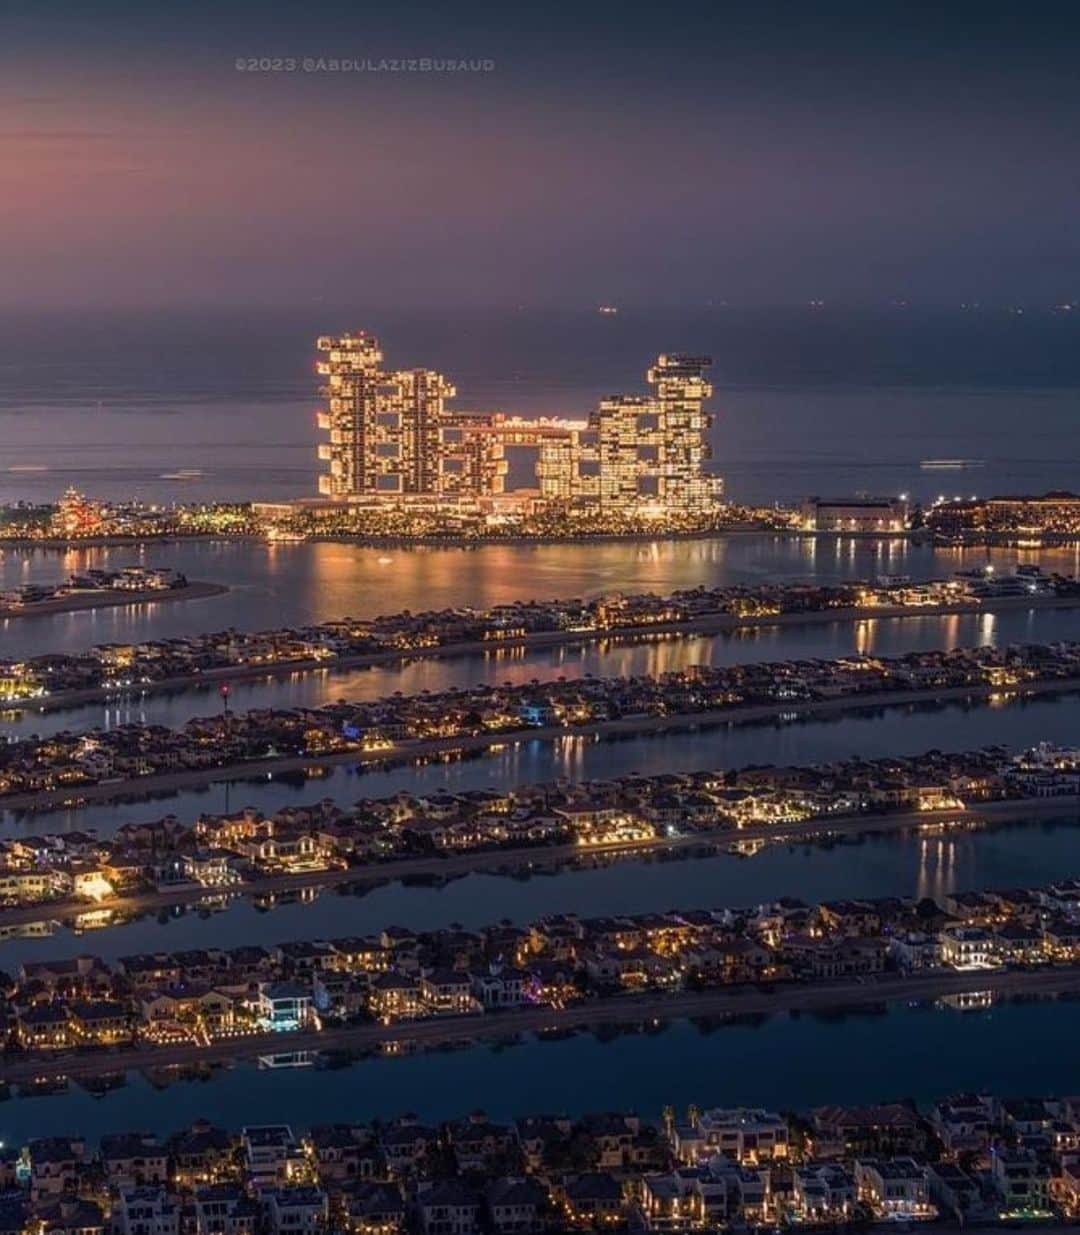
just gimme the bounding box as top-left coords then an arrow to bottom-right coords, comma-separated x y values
0,534 -> 1080,656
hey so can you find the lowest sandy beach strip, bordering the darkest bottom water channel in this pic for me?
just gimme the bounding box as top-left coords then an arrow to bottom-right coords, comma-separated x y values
0,965 -> 1080,1084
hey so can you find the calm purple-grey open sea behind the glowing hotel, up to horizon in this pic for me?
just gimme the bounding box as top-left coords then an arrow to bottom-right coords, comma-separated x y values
0,305 -> 1080,501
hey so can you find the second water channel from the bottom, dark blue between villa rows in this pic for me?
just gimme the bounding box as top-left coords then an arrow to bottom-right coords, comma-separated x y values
0,816 -> 1080,969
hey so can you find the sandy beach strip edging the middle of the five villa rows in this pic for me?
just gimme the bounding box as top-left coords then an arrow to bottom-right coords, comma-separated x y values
0,795 -> 1080,931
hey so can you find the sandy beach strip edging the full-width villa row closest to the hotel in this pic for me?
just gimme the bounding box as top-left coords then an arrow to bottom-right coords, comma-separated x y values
14,584 -> 1080,716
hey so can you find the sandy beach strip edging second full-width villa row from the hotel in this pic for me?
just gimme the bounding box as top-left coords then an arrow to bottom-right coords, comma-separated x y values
0,677 -> 1080,810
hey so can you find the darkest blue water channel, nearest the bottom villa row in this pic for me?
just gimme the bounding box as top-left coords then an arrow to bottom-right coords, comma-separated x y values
2,1000 -> 1080,1144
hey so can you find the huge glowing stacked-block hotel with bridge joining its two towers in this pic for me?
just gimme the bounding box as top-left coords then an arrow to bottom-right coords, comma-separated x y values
318,332 -> 722,517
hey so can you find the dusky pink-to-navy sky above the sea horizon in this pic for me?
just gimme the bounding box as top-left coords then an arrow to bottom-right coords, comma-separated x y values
0,0 -> 1080,310
